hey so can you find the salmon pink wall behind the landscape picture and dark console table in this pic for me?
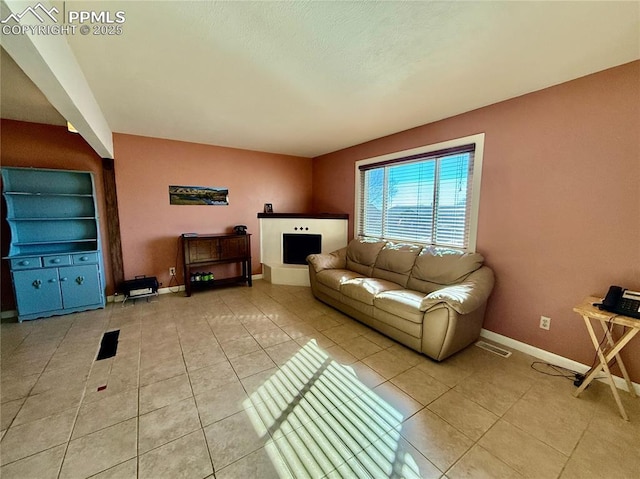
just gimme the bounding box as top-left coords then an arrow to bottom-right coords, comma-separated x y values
114,134 -> 311,286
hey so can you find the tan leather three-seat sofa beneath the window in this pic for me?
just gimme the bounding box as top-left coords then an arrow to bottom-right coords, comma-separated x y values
307,239 -> 494,361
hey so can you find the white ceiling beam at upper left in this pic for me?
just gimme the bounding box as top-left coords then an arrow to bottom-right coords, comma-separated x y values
0,0 -> 113,158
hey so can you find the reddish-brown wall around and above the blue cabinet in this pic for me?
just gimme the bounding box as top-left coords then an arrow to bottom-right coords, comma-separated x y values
0,120 -> 113,311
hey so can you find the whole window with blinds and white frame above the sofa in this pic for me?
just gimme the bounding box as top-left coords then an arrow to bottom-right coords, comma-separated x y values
356,134 -> 484,251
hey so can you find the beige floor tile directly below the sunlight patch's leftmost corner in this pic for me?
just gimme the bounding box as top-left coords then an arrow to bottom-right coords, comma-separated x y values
204,411 -> 269,471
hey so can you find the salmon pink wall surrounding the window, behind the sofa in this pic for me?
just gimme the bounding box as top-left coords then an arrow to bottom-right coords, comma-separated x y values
313,61 -> 640,382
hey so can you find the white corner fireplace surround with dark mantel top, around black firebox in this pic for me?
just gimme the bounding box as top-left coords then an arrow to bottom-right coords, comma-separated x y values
258,213 -> 349,286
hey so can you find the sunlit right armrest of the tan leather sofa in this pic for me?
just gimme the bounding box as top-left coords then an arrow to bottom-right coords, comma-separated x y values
420,266 -> 494,314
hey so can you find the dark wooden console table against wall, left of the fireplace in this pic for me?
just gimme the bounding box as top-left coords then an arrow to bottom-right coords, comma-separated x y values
182,234 -> 252,296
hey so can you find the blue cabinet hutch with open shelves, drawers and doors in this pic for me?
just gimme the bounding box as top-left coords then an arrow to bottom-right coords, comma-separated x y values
2,168 -> 105,321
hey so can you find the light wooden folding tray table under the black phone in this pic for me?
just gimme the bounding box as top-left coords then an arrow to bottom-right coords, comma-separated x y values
573,296 -> 640,421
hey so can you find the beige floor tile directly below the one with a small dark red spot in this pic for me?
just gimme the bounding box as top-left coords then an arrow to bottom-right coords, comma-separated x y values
72,389 -> 138,439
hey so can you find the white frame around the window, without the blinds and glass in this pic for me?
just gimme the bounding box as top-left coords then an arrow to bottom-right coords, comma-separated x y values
354,133 -> 485,253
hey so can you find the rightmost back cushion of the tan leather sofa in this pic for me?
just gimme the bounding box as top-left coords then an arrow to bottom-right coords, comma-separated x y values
407,247 -> 484,293
